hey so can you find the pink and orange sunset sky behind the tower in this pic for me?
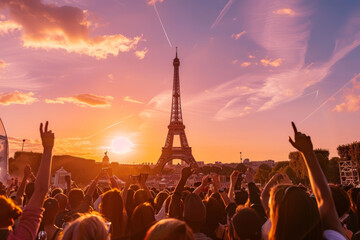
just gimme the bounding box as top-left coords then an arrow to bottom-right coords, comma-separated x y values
0,0 -> 360,163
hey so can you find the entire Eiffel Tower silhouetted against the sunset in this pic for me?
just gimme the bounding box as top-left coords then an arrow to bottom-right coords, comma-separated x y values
154,48 -> 198,173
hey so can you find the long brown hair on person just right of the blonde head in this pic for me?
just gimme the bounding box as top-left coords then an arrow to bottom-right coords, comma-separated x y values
100,189 -> 125,238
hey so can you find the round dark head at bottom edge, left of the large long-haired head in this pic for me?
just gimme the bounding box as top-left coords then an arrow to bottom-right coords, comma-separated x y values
230,207 -> 262,240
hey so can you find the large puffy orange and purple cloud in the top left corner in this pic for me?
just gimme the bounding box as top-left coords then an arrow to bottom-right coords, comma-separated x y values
0,0 -> 141,59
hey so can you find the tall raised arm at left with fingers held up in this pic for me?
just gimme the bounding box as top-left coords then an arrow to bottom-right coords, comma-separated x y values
28,122 -> 55,208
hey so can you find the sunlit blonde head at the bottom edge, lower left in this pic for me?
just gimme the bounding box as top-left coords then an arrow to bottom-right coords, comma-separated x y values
62,213 -> 108,240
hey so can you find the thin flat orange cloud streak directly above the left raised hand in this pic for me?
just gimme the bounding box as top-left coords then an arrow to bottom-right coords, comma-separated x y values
45,93 -> 114,108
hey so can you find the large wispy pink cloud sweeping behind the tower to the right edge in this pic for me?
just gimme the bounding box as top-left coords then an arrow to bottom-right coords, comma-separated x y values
143,0 -> 360,120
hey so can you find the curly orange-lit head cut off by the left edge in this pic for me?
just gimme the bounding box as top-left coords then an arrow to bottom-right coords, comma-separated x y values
0,196 -> 22,228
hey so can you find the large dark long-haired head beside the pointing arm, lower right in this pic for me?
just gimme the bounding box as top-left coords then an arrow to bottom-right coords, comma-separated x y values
269,185 -> 321,240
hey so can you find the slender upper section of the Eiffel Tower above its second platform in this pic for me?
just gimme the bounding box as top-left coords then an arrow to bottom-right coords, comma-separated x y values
170,47 -> 183,125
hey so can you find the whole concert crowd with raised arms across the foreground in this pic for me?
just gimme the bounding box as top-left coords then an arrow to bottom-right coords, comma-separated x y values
0,122 -> 360,240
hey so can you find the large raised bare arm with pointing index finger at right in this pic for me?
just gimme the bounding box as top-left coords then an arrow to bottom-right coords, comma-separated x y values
289,122 -> 345,236
